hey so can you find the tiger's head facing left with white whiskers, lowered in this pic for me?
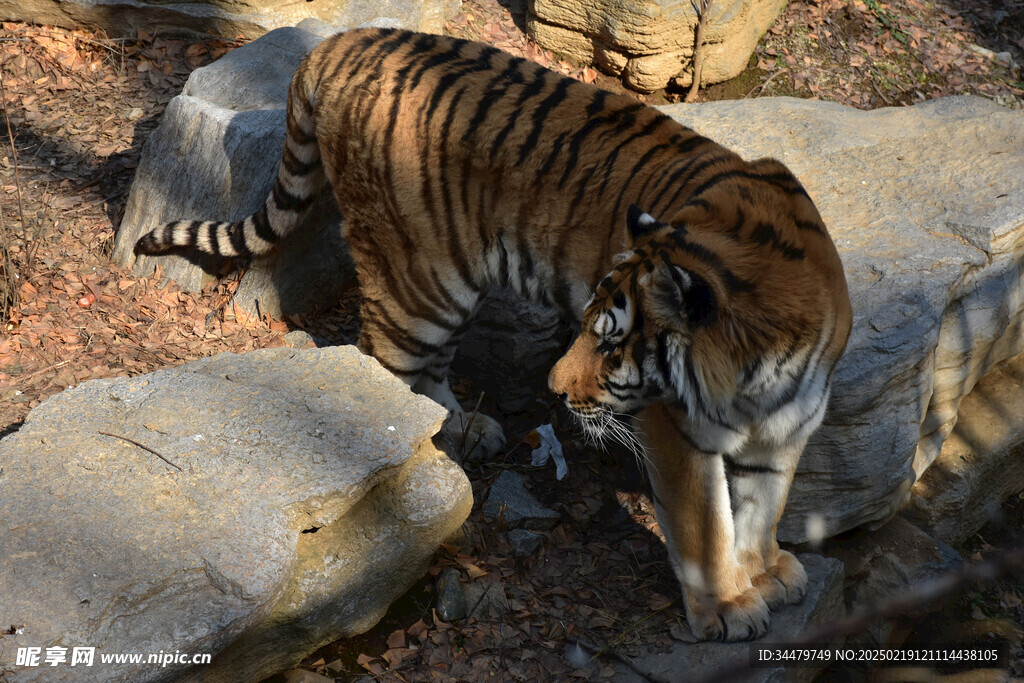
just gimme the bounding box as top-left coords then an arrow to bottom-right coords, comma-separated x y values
548,205 -> 727,445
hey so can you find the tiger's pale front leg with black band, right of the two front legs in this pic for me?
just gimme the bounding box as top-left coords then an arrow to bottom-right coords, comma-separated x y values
727,439 -> 807,607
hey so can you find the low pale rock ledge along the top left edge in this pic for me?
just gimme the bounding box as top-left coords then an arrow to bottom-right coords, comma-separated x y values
0,0 -> 462,38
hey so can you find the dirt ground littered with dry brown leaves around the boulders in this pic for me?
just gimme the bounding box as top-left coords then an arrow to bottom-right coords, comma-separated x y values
0,0 -> 1024,680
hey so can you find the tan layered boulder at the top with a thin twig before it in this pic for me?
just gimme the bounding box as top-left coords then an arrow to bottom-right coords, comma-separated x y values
526,0 -> 786,92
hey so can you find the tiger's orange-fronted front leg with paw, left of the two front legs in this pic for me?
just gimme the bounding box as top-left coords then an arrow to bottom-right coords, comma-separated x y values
636,403 -> 769,641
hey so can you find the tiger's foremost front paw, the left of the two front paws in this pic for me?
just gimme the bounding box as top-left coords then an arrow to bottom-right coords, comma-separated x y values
683,588 -> 771,642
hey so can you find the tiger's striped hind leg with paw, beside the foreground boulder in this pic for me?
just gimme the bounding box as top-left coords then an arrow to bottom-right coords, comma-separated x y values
349,254 -> 506,458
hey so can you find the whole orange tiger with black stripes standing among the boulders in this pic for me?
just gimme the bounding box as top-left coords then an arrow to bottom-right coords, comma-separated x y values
135,29 -> 851,641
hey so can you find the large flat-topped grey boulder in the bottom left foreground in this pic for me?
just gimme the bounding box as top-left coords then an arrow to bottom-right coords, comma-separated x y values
0,347 -> 472,681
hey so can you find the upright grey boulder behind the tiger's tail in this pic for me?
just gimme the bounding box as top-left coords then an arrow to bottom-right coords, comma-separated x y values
114,20 -> 355,316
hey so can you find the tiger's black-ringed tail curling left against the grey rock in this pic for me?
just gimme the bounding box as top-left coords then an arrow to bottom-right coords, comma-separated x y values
135,60 -> 324,258
